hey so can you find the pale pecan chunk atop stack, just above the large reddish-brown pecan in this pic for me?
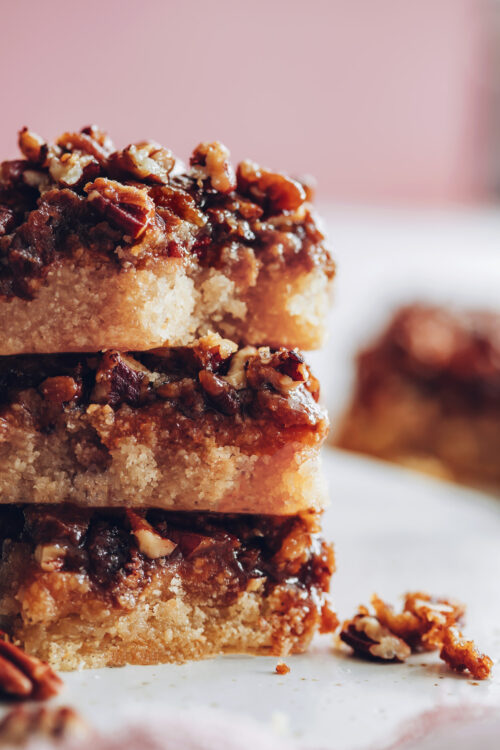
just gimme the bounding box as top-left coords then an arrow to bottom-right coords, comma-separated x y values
110,142 -> 175,185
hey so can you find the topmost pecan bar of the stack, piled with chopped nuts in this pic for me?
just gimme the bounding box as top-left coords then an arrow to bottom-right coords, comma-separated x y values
0,127 -> 334,354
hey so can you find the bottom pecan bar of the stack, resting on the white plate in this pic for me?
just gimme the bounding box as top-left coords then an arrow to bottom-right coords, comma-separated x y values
0,505 -> 336,670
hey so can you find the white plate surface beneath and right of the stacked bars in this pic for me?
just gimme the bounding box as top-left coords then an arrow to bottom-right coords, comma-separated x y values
13,450 -> 500,750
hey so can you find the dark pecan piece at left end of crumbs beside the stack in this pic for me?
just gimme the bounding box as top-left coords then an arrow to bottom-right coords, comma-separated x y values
340,607 -> 411,662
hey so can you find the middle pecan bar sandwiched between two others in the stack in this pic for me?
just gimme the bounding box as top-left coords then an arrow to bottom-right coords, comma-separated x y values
0,334 -> 328,515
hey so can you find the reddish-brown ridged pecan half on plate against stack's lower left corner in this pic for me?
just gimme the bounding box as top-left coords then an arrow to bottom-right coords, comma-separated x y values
0,640 -> 62,700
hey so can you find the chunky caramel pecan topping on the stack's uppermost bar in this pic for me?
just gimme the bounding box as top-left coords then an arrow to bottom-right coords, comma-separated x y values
0,125 -> 334,299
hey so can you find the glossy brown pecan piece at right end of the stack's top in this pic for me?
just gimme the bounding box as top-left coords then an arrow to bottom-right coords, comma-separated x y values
237,160 -> 306,215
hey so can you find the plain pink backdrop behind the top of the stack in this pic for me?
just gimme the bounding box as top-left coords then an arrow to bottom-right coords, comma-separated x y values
0,0 -> 491,203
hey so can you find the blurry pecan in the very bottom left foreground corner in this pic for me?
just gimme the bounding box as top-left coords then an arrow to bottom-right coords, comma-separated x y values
0,706 -> 89,747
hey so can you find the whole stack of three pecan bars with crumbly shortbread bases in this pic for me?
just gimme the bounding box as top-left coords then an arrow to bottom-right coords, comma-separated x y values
0,127 -> 336,669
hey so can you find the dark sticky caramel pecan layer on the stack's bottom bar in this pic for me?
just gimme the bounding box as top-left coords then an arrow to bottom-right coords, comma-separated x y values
0,505 -> 334,607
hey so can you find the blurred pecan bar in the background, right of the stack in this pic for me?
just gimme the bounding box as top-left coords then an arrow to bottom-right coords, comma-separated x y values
337,306 -> 500,487
